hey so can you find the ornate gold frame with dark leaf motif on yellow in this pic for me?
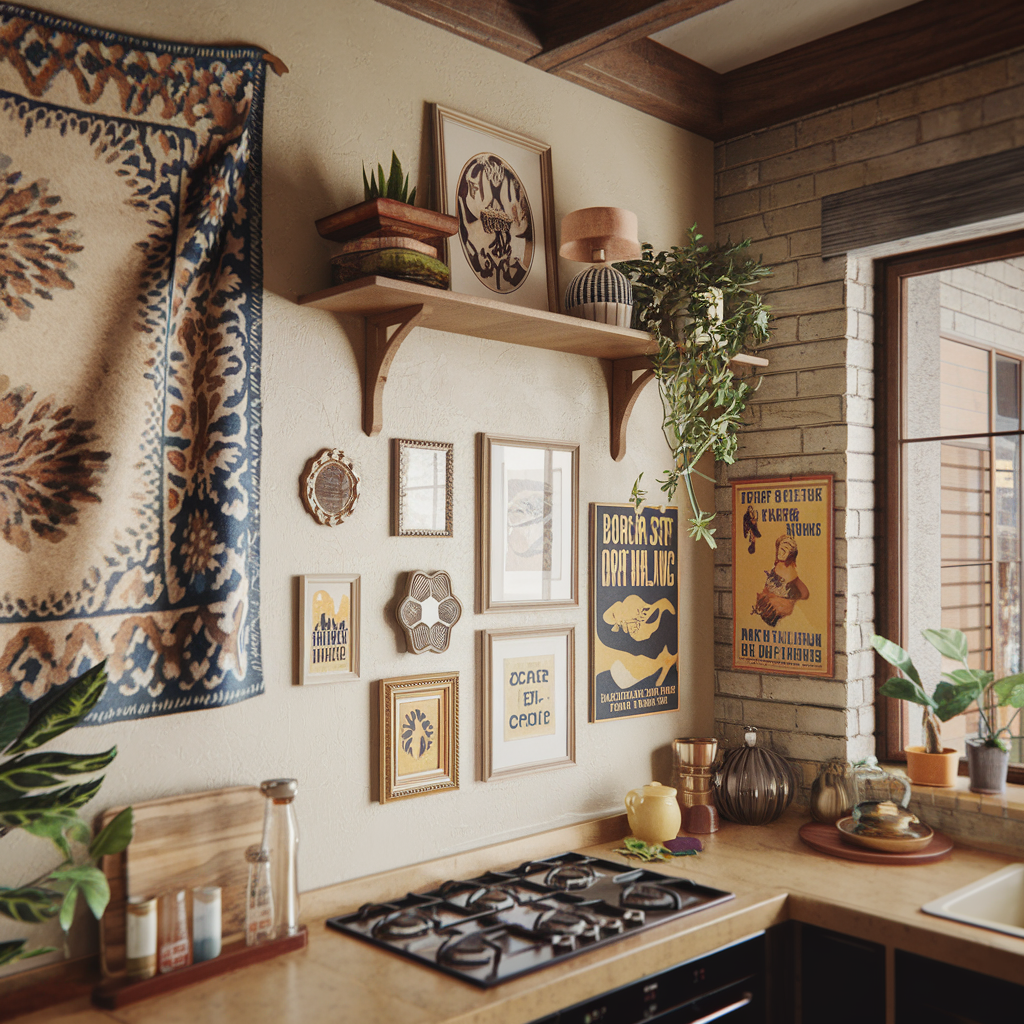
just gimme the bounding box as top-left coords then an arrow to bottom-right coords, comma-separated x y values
380,673 -> 459,804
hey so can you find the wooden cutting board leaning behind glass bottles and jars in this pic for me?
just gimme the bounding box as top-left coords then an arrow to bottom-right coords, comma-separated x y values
99,785 -> 266,976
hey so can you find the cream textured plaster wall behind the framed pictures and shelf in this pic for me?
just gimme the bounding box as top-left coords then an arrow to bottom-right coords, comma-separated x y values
4,0 -> 713,965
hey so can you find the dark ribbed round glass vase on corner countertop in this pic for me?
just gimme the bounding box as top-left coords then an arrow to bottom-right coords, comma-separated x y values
715,726 -> 797,825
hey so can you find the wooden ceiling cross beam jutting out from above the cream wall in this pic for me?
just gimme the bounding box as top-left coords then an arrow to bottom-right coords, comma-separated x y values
526,0 -> 728,72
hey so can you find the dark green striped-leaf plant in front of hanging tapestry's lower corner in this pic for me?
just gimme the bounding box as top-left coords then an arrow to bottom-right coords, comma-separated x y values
0,663 -> 132,966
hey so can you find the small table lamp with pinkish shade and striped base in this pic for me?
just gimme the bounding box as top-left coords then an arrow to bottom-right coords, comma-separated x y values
558,206 -> 640,327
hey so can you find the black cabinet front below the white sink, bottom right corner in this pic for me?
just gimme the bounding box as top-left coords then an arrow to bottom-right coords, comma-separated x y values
896,949 -> 1024,1024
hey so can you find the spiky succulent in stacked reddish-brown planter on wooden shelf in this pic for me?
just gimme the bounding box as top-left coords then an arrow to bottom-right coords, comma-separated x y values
316,153 -> 459,289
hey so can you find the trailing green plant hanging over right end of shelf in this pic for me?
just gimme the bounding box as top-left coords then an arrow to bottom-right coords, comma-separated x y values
615,231 -> 771,548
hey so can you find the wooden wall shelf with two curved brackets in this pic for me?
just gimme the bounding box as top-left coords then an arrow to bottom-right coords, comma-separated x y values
299,278 -> 768,462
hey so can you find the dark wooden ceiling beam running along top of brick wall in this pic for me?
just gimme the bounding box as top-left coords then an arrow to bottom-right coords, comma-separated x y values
713,0 -> 1024,138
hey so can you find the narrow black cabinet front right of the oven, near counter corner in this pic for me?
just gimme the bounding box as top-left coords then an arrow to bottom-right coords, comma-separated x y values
797,925 -> 884,1024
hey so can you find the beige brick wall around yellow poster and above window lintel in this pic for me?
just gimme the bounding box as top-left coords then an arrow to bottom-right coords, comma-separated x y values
715,50 -> 1024,779
